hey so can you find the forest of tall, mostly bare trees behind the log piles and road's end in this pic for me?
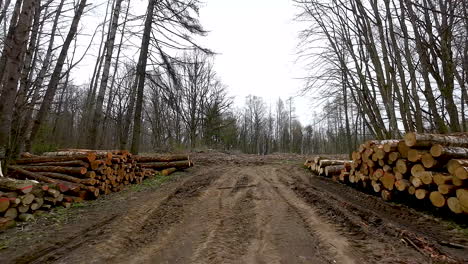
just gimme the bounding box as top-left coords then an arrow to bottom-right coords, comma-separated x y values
0,0 -> 468,171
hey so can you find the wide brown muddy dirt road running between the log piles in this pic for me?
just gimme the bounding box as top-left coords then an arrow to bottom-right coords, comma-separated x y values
0,155 -> 468,263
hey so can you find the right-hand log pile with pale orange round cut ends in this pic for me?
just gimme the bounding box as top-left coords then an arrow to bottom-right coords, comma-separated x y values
306,132 -> 468,215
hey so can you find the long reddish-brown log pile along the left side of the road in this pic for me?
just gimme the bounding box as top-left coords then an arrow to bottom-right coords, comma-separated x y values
0,149 -> 193,229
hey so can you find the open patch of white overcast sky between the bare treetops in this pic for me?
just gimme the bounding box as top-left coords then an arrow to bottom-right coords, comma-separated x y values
200,0 -> 312,124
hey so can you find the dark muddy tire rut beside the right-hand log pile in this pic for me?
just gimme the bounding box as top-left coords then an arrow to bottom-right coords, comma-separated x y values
282,169 -> 458,263
